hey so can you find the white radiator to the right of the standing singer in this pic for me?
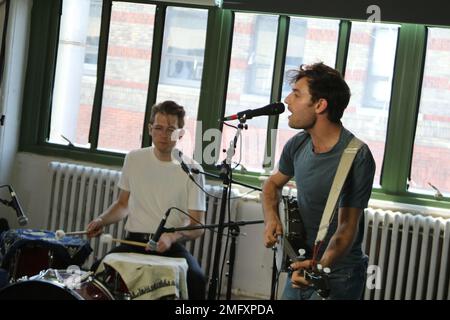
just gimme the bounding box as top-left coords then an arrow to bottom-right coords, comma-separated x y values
363,208 -> 450,300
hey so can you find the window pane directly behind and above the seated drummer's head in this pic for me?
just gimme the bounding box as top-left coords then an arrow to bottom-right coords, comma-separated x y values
156,7 -> 208,156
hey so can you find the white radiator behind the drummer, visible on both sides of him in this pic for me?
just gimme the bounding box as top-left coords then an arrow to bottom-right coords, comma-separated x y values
47,162 -> 237,280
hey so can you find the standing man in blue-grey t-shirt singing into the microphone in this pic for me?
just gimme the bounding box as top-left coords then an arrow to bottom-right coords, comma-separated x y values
263,63 -> 375,299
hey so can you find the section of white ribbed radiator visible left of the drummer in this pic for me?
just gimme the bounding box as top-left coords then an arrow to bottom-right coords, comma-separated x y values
47,162 -> 125,267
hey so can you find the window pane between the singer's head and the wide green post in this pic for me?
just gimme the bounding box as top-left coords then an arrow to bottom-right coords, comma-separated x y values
342,22 -> 399,186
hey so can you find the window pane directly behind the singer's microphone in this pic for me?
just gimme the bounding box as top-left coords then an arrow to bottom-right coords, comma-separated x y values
222,13 -> 278,171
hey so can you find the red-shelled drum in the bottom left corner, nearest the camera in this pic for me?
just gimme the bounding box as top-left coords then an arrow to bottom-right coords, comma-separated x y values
0,269 -> 114,300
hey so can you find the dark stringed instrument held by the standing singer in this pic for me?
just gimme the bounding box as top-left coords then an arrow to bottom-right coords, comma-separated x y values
274,197 -> 331,298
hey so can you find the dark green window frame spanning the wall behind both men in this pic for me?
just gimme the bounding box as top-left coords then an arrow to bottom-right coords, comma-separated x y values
19,0 -> 450,209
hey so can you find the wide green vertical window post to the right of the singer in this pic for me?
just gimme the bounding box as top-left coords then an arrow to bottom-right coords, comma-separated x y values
381,24 -> 426,194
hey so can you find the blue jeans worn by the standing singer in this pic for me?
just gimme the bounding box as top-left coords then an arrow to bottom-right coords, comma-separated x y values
281,257 -> 368,300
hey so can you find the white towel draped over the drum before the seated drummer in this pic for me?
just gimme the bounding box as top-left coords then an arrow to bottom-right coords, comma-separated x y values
96,252 -> 188,300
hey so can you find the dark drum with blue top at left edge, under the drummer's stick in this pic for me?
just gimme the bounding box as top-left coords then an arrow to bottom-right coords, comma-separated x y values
0,229 -> 92,281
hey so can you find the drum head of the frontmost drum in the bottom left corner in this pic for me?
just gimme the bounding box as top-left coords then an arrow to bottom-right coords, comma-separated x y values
0,280 -> 81,300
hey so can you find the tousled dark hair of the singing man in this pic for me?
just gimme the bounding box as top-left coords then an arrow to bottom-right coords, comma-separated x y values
288,62 -> 350,123
